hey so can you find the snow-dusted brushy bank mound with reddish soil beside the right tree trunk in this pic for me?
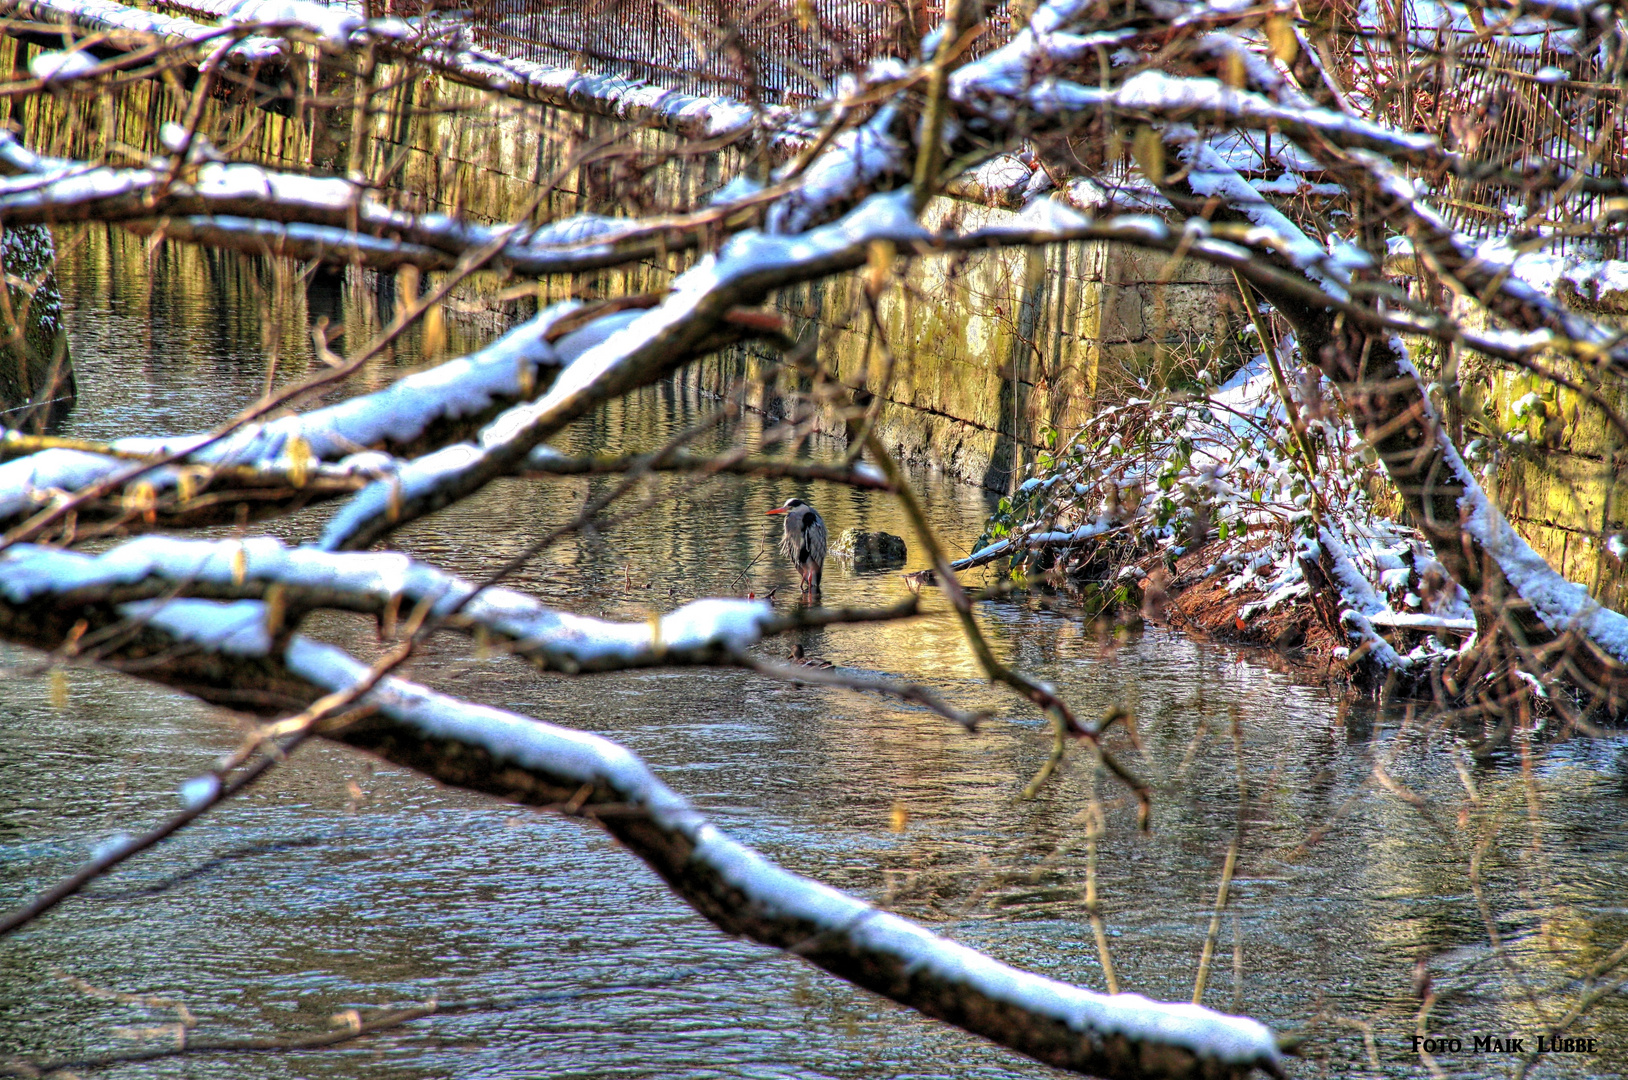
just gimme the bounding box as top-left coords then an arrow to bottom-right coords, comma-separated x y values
957,346 -> 1497,691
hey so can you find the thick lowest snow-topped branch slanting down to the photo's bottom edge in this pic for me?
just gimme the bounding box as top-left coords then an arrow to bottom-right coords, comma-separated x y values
302,651 -> 1280,1077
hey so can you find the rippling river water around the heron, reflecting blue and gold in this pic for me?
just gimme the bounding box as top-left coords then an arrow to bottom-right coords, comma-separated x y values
0,230 -> 1628,1080
